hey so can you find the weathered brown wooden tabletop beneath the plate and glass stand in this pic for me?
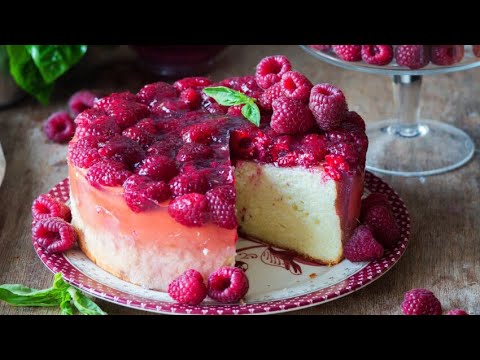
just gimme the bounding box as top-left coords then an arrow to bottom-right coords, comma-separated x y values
0,46 -> 480,314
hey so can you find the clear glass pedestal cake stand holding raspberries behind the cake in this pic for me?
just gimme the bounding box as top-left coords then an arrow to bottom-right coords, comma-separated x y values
301,45 -> 480,176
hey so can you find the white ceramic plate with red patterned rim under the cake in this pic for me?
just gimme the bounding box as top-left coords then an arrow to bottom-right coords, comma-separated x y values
33,172 -> 410,315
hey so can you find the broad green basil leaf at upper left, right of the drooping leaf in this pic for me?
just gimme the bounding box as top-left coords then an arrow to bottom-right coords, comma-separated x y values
25,45 -> 87,84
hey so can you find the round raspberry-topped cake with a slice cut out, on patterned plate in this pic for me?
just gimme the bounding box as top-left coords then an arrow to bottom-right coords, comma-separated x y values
68,56 -> 368,290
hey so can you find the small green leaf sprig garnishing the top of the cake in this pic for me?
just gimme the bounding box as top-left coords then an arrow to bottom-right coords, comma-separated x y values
203,86 -> 260,126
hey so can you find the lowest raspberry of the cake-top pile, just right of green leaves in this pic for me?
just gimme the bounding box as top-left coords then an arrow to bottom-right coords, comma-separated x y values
270,97 -> 315,134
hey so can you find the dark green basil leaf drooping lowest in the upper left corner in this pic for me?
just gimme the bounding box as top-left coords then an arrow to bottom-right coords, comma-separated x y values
6,45 -> 53,105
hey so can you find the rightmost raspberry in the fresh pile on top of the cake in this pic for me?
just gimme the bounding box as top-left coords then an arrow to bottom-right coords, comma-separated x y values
309,84 -> 348,131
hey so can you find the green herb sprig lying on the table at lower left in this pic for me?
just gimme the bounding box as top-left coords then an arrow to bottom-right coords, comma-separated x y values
0,273 -> 107,315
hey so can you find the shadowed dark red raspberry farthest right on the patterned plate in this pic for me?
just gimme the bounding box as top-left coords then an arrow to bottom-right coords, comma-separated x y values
360,205 -> 400,248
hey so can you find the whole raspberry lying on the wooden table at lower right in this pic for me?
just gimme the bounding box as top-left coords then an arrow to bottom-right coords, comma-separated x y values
402,289 -> 442,315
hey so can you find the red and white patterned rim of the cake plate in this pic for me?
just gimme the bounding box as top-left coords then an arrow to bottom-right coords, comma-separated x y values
33,171 -> 410,315
